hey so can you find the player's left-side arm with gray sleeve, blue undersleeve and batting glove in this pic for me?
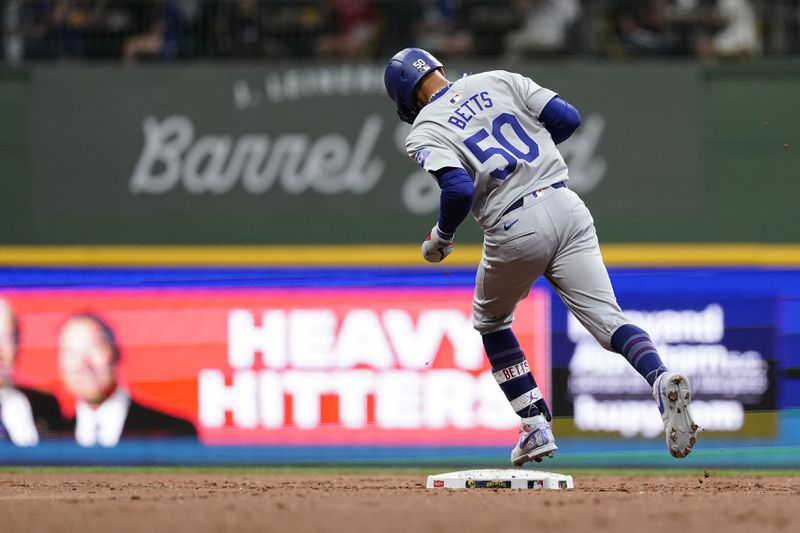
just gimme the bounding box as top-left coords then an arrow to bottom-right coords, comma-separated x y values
406,130 -> 475,263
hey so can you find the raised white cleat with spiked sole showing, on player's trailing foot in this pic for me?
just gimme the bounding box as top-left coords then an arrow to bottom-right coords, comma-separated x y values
653,372 -> 700,459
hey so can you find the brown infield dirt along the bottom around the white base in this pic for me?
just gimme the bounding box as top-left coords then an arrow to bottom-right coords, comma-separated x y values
0,471 -> 800,533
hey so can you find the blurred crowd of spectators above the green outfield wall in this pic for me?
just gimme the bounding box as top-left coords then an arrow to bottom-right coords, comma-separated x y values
2,0 -> 800,63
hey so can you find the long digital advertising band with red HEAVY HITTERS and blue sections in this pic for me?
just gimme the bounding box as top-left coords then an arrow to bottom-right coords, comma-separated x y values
0,269 -> 798,454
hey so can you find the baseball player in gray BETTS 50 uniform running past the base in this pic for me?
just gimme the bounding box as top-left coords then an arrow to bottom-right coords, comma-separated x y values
384,48 -> 698,466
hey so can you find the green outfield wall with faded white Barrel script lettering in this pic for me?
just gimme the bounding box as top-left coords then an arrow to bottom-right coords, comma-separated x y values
0,63 -> 800,245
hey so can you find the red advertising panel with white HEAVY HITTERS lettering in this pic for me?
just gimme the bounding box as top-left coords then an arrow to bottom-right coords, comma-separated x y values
2,288 -> 550,445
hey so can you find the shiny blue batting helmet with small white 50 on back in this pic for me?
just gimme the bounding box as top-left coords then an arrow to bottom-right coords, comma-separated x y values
383,48 -> 442,124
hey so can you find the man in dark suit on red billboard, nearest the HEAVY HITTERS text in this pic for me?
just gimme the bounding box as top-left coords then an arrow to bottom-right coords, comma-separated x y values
59,313 -> 197,447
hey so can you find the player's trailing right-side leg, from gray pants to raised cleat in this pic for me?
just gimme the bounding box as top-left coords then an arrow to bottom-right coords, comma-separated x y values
545,189 -> 698,458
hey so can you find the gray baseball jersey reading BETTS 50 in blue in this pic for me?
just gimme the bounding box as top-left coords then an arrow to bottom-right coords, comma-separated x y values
406,70 -> 569,229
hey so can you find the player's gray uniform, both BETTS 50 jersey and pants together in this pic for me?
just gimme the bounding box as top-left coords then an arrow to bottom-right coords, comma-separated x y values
406,71 -> 630,348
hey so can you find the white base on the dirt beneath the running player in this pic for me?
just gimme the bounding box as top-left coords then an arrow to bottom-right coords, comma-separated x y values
427,469 -> 575,490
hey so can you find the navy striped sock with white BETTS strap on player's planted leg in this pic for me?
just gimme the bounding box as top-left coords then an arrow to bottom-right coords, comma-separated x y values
483,329 -> 552,422
